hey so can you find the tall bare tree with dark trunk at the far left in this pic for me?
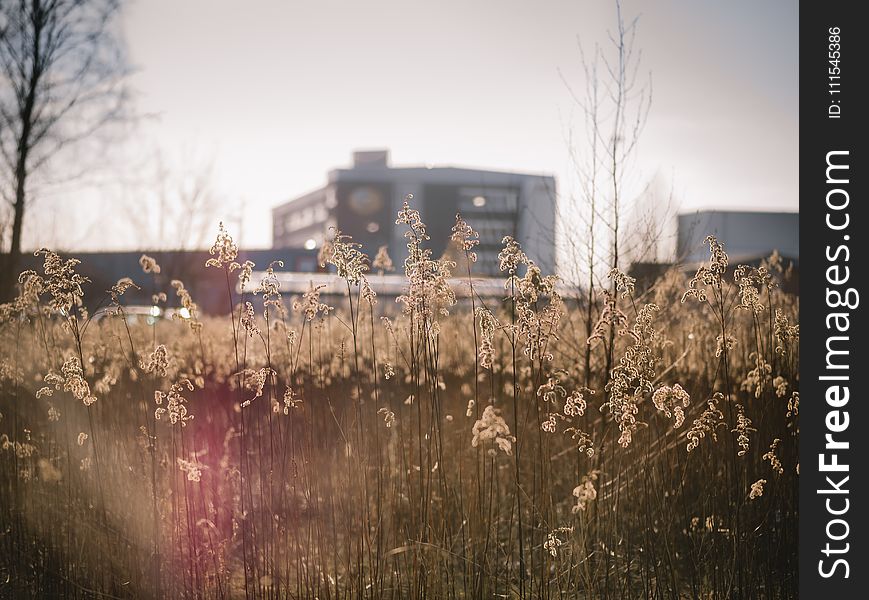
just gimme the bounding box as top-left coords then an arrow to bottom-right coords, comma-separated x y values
0,0 -> 126,294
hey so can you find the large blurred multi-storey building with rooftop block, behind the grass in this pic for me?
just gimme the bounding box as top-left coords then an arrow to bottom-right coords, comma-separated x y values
272,150 -> 555,275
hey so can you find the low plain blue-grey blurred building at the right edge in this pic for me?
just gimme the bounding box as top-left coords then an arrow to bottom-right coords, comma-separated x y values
676,210 -> 800,264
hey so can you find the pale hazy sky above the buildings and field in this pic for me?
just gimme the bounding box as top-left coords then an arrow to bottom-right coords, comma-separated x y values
27,0 -> 798,250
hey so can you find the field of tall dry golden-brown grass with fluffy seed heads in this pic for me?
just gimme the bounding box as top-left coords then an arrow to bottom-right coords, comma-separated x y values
0,204 -> 799,600
